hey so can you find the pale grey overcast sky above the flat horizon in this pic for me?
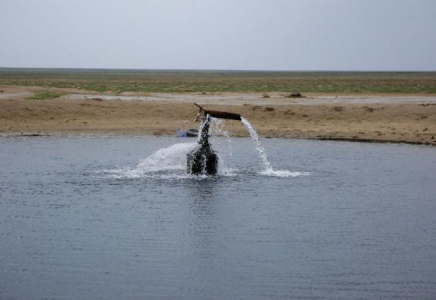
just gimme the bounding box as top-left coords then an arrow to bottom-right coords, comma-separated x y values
0,0 -> 436,71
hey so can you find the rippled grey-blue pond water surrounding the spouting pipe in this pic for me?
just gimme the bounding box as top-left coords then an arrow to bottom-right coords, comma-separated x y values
0,136 -> 436,300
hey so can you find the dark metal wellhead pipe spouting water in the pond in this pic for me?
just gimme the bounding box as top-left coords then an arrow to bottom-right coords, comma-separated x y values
187,103 -> 241,175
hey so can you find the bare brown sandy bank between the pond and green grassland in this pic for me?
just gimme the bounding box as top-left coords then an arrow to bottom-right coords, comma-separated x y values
0,86 -> 436,145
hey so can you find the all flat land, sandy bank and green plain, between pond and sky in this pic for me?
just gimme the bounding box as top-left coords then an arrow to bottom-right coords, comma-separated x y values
0,70 -> 436,145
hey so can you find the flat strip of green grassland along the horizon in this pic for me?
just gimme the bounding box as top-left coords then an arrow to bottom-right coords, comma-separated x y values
0,68 -> 436,94
